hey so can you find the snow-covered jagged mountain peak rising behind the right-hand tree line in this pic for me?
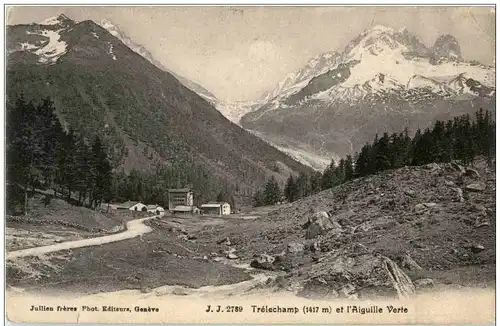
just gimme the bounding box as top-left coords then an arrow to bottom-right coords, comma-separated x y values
241,26 -> 496,169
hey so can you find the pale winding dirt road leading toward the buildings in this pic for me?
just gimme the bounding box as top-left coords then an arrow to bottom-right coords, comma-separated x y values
7,216 -> 156,259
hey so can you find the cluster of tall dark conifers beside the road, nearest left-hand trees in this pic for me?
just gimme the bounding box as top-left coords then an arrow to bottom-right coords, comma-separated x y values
6,97 -> 112,214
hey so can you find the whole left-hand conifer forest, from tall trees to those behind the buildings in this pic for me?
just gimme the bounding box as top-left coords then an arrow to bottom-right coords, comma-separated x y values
6,97 -> 238,215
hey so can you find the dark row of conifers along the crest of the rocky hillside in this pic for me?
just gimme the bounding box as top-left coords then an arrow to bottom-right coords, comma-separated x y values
253,109 -> 496,206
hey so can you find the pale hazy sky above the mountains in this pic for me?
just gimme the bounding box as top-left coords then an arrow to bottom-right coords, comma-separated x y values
6,6 -> 495,101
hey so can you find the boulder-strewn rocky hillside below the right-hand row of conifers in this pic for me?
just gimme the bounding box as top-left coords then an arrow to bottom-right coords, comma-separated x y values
196,161 -> 496,299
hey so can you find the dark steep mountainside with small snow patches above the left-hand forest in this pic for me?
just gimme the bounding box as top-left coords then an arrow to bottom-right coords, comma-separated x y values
6,15 -> 309,201
